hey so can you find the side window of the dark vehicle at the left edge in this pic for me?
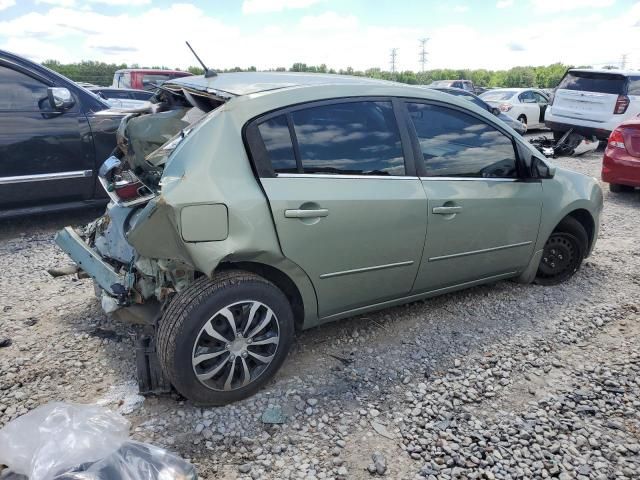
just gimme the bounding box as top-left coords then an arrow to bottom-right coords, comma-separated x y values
0,65 -> 51,112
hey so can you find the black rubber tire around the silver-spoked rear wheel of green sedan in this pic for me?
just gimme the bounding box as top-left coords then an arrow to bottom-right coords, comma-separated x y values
157,270 -> 294,405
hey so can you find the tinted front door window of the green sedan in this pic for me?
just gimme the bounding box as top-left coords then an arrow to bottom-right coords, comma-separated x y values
407,103 -> 517,178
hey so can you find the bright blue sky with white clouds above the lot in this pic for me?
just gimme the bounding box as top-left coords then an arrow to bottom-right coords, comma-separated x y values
0,0 -> 640,70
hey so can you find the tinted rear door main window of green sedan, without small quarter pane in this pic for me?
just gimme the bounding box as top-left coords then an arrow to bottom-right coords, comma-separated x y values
291,101 -> 404,175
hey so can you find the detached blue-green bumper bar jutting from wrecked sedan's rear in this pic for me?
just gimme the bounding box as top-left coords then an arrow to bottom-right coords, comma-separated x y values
55,227 -> 129,306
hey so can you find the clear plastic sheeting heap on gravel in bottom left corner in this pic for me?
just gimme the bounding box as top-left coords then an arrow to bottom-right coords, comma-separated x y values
0,402 -> 197,480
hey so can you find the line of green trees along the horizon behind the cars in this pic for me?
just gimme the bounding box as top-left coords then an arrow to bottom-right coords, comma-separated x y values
43,60 -> 571,88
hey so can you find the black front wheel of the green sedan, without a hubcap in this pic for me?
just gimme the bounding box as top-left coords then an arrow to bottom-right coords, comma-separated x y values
535,217 -> 589,285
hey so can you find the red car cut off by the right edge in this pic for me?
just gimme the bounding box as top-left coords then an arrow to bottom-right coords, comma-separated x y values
602,117 -> 640,192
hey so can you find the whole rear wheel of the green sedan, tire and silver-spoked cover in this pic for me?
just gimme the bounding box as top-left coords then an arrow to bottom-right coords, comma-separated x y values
157,271 -> 294,405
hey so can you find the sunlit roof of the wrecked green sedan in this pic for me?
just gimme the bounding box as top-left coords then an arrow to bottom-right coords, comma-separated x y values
168,72 -> 404,96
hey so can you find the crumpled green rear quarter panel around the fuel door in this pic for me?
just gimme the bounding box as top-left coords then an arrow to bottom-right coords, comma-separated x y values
127,106 -> 318,328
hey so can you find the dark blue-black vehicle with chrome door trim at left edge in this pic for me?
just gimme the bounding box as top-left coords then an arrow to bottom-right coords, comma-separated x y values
0,51 -> 129,218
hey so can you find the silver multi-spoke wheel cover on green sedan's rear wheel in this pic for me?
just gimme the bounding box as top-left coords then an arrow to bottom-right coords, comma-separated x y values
192,300 -> 280,391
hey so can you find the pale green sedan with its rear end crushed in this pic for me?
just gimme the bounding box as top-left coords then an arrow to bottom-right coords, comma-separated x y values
56,72 -> 602,405
